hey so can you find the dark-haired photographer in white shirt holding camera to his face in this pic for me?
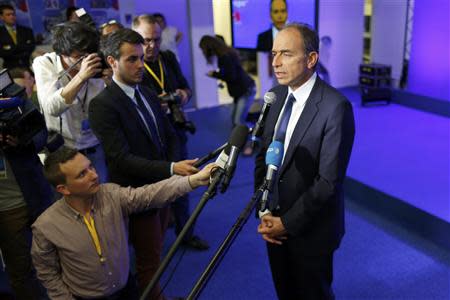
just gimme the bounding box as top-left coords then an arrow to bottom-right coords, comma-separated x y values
33,22 -> 107,182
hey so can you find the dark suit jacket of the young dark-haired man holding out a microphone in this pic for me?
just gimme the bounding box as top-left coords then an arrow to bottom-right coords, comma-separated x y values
89,82 -> 179,187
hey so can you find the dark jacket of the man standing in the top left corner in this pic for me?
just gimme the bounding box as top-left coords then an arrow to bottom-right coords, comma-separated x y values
0,25 -> 35,69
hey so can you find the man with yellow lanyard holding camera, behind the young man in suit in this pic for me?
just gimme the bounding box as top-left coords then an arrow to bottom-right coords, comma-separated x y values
133,15 -> 209,250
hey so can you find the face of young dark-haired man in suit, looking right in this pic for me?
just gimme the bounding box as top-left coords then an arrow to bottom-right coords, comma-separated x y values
108,43 -> 144,85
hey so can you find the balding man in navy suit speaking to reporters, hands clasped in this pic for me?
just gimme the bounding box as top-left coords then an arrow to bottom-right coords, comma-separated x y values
255,24 -> 355,299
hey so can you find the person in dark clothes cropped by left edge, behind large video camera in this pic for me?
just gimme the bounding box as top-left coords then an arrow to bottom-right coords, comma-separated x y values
0,100 -> 53,300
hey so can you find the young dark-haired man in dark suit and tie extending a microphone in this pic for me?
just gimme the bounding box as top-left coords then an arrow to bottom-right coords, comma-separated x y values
89,29 -> 198,299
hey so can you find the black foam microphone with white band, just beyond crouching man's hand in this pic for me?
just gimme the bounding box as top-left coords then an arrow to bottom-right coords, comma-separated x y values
220,125 -> 249,193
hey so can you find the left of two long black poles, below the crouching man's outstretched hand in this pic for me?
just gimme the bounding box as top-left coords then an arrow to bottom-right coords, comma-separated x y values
139,168 -> 225,300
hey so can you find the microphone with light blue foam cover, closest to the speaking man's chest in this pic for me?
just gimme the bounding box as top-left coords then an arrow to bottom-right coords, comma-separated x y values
258,141 -> 284,218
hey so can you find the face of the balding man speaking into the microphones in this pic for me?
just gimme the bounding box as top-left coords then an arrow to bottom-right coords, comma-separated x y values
272,28 -> 318,90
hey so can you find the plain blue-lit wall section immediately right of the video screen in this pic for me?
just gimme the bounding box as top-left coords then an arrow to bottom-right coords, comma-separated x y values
319,0 -> 364,87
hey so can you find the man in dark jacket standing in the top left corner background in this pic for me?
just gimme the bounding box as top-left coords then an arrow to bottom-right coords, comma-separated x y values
0,4 -> 35,69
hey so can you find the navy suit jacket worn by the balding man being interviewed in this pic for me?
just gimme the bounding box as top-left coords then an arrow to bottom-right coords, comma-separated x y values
255,77 -> 355,254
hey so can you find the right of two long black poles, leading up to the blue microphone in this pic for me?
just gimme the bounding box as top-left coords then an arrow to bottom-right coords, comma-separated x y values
186,181 -> 268,300
